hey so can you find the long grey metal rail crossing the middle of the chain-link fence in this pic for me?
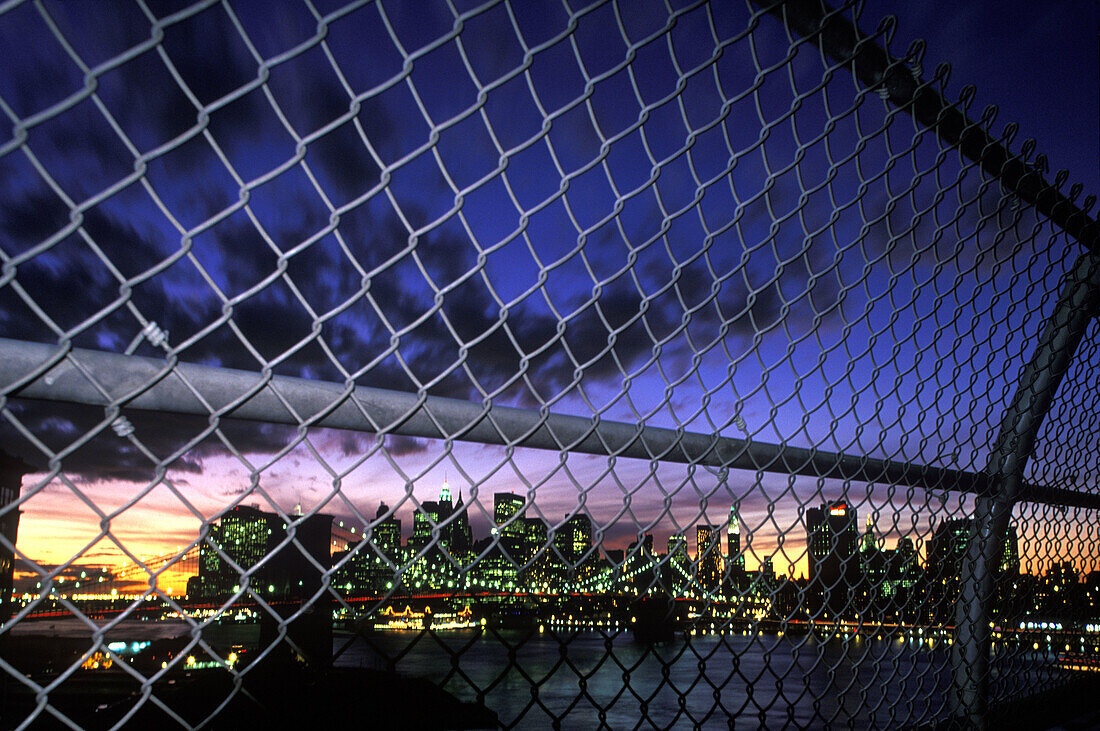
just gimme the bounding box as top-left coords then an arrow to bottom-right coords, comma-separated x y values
0,339 -> 1100,509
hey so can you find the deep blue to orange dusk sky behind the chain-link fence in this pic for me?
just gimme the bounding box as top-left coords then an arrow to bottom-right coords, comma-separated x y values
0,1 -> 1100,589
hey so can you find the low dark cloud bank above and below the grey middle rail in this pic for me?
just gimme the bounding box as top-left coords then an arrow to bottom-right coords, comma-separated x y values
2,193 -> 708,481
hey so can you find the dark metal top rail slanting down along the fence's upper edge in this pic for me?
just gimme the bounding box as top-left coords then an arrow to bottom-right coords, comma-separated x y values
754,0 -> 1100,252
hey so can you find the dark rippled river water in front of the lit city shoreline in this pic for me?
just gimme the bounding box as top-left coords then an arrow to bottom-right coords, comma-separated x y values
337,631 -> 950,729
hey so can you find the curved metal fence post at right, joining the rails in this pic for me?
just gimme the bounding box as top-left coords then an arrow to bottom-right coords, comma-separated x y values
950,252 -> 1100,728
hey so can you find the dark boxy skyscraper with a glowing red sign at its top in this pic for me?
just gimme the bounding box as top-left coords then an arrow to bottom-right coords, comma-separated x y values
806,500 -> 860,617
